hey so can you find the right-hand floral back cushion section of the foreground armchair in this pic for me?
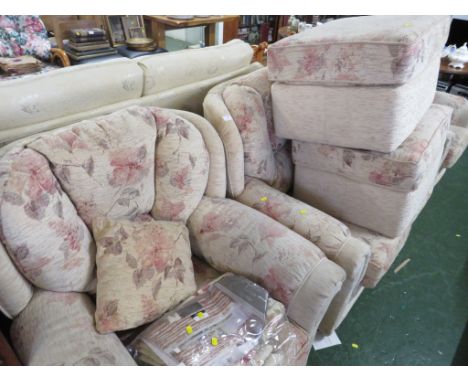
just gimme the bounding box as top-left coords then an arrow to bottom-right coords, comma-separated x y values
149,107 -> 210,222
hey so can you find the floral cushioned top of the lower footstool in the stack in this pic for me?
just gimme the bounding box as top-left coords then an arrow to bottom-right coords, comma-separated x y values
293,104 -> 451,192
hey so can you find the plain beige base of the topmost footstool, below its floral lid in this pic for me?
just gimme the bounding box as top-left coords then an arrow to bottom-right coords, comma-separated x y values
271,59 -> 439,152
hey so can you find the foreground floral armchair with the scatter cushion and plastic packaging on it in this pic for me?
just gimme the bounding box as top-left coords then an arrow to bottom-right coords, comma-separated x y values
0,107 -> 345,365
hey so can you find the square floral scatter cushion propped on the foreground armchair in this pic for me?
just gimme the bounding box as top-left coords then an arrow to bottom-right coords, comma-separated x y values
93,217 -> 196,333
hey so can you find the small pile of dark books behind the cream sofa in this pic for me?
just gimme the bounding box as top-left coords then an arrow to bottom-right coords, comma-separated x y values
65,28 -> 117,61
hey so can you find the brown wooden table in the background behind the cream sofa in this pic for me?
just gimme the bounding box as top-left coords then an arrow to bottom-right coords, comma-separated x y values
143,15 -> 239,48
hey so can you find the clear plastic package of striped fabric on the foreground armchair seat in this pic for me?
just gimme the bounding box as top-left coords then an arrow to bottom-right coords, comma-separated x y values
129,273 -> 309,366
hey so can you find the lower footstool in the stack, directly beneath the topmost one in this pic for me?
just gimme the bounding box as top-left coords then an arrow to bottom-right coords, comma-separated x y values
293,104 -> 452,238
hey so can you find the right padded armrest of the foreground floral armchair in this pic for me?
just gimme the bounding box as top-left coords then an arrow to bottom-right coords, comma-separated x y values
188,197 -> 345,335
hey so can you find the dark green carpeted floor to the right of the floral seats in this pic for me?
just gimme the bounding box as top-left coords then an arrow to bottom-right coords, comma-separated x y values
308,153 -> 468,366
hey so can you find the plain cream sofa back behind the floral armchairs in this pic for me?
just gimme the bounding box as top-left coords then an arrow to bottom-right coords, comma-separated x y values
0,40 -> 262,145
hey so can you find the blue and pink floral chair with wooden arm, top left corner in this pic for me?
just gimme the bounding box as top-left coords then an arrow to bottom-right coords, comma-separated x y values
0,15 -> 70,66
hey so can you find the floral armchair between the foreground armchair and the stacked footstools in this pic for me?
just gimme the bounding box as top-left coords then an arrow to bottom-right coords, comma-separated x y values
203,68 -> 370,333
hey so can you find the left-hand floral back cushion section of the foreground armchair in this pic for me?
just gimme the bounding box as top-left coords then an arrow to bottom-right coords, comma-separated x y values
0,148 -> 95,291
